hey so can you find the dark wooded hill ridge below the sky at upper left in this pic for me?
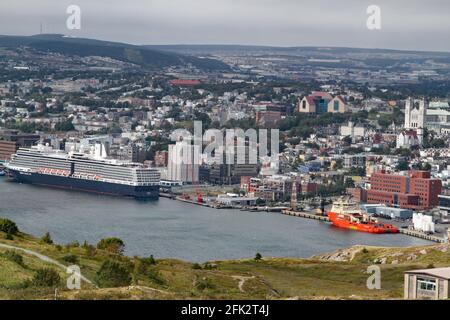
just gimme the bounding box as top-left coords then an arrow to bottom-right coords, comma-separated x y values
0,34 -> 229,70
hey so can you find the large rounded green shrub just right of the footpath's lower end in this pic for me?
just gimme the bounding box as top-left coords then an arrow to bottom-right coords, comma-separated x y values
95,260 -> 131,288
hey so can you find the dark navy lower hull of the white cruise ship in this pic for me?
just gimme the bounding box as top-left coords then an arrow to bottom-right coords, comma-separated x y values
8,169 -> 159,199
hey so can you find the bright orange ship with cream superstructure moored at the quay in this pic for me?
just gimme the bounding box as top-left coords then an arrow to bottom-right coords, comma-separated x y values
327,200 -> 398,233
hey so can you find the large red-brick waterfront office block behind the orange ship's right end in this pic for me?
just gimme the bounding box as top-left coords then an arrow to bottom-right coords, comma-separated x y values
367,171 -> 442,210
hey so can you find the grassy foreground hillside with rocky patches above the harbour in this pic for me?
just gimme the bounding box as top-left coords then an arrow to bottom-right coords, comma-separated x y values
0,222 -> 450,299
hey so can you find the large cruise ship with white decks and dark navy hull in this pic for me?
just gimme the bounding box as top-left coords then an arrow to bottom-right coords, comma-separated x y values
5,145 -> 160,199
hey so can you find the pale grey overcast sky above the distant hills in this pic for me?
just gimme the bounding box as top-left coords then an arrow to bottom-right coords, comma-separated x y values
0,0 -> 450,51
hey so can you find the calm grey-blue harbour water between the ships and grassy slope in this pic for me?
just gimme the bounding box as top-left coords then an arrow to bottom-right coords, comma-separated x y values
0,177 -> 430,262
